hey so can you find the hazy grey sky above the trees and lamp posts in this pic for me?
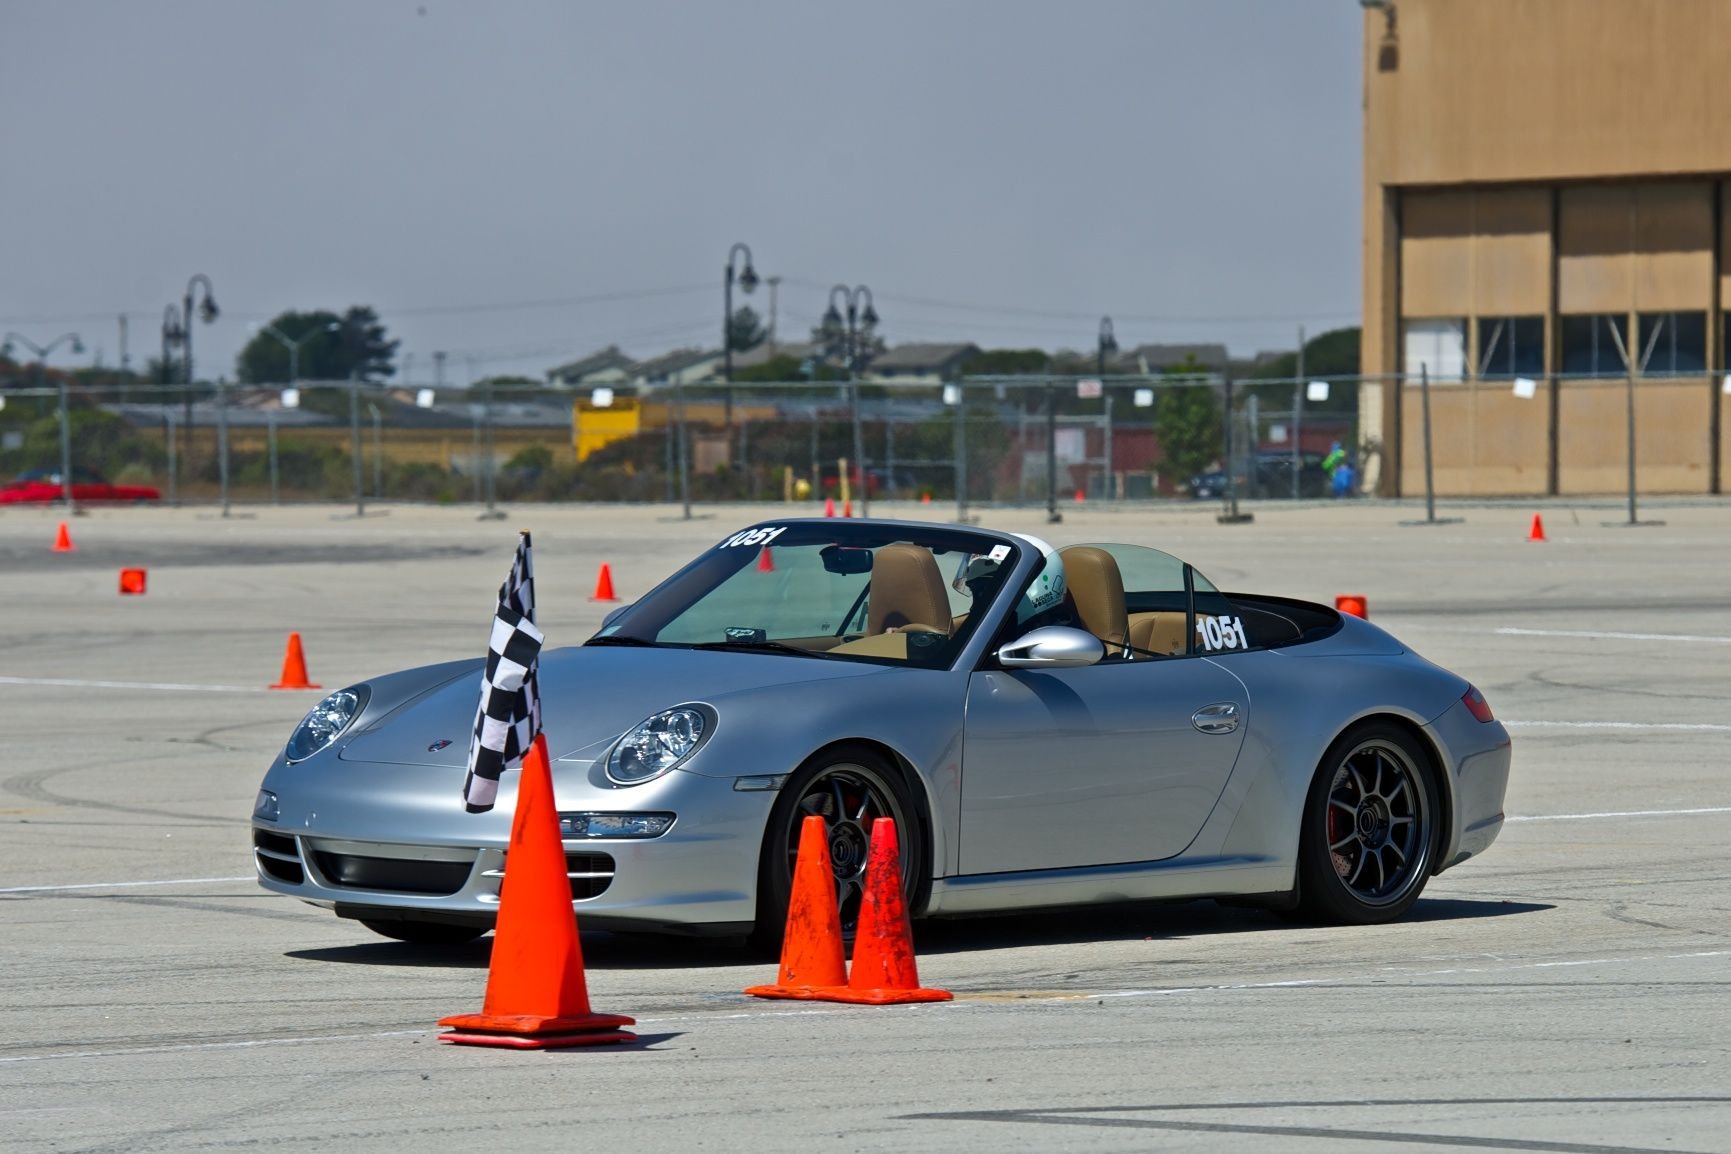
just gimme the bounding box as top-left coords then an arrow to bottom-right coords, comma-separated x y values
0,0 -> 1362,381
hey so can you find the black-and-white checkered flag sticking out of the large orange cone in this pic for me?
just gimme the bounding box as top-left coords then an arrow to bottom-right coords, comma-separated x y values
462,533 -> 544,813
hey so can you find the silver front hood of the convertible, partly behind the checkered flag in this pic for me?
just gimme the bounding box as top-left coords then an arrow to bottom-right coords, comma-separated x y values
338,645 -> 895,768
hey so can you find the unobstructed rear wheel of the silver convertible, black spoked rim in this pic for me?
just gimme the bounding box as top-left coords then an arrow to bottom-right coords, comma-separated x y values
1298,721 -> 1442,926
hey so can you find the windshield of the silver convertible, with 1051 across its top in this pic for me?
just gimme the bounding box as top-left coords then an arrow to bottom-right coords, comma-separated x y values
589,521 -> 1020,668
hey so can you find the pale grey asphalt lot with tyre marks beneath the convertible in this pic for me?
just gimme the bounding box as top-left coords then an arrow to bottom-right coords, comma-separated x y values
0,502 -> 1731,1154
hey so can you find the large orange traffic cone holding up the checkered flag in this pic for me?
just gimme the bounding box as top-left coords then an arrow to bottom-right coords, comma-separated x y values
438,735 -> 637,1050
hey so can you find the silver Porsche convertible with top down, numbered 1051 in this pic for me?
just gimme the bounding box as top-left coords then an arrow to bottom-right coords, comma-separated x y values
253,519 -> 1509,943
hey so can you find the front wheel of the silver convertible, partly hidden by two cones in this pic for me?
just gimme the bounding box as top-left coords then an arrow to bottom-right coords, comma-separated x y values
751,746 -> 926,952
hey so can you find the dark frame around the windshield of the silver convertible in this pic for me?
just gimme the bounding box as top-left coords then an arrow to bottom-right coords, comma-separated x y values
585,517 -> 1040,671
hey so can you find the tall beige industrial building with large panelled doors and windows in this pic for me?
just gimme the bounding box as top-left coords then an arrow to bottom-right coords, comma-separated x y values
1361,0 -> 1731,495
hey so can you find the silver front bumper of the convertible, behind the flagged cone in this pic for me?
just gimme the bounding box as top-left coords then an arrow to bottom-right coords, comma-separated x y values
253,763 -> 775,933
